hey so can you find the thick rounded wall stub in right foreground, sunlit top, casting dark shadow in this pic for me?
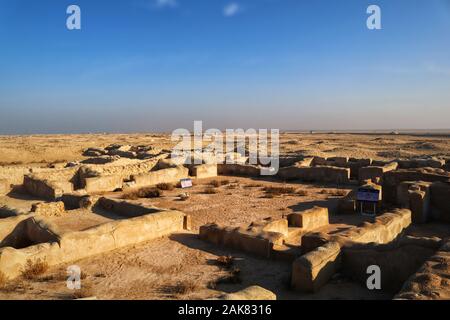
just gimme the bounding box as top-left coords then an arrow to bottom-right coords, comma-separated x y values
291,242 -> 341,292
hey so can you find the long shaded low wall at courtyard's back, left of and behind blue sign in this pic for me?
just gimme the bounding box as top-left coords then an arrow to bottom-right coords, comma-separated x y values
278,166 -> 350,184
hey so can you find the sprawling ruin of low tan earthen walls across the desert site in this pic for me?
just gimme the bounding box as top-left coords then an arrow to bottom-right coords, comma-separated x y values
0,145 -> 450,299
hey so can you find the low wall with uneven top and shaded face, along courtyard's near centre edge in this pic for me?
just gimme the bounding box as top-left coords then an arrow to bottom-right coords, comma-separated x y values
199,224 -> 284,258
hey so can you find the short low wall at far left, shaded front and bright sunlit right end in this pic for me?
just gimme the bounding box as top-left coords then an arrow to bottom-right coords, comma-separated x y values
23,175 -> 73,200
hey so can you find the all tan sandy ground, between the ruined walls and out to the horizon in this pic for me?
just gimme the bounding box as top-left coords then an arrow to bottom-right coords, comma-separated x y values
0,134 -> 450,299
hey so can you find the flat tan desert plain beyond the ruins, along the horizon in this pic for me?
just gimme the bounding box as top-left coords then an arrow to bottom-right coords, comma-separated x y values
0,133 -> 450,164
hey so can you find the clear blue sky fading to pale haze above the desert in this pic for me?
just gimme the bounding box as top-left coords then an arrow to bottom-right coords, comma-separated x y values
0,0 -> 450,134
